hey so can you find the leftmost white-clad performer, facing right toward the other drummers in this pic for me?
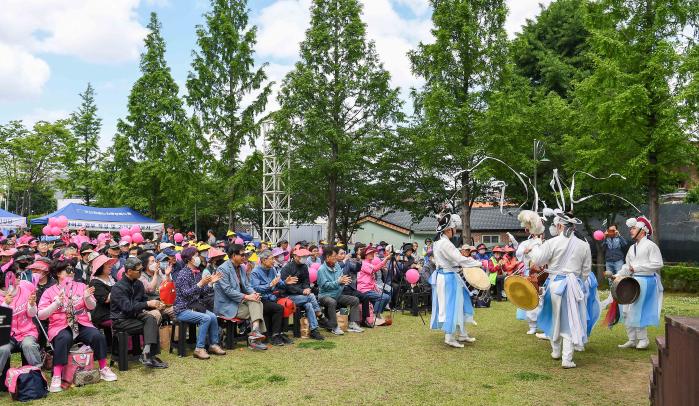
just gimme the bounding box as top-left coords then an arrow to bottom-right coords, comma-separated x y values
430,213 -> 481,348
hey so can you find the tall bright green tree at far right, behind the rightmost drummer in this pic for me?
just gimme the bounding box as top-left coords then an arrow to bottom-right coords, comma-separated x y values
570,0 -> 699,243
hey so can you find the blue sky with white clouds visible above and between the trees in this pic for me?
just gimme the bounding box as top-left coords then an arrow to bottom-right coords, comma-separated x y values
0,0 -> 549,148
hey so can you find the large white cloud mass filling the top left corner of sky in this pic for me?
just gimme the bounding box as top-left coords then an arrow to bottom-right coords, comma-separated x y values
0,0 -> 149,99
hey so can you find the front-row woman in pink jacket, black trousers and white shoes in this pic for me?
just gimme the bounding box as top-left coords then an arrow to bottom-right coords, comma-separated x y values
39,260 -> 117,392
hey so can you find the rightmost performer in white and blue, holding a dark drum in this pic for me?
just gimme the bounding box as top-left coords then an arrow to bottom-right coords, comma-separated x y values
616,216 -> 663,349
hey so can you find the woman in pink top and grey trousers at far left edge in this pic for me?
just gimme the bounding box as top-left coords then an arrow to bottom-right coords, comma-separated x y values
0,265 -> 41,368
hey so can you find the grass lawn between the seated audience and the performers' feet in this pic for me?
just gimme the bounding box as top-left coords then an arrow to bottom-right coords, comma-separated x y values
6,292 -> 699,405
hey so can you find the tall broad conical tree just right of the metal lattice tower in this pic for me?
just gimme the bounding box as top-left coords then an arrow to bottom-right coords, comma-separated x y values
275,0 -> 405,241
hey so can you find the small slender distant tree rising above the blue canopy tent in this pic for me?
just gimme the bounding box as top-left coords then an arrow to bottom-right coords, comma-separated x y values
57,83 -> 102,205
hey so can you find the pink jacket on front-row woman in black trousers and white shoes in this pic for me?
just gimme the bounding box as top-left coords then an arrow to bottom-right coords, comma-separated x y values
39,282 -> 95,341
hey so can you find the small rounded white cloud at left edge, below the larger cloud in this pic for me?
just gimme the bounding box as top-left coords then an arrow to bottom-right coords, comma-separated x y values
0,42 -> 51,101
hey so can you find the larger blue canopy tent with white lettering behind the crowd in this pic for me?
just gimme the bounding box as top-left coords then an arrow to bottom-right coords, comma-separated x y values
31,203 -> 163,233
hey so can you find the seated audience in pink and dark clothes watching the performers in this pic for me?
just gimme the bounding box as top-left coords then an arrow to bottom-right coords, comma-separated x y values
0,226 -> 521,398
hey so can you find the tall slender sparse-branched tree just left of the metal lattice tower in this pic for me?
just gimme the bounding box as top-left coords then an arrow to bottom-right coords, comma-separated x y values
186,0 -> 272,228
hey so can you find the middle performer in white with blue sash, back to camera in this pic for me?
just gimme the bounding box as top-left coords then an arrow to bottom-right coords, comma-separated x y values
524,213 -> 592,368
